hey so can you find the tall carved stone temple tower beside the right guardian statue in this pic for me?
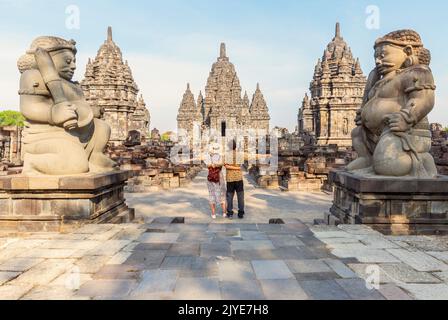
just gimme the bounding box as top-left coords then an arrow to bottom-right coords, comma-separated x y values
298,23 -> 366,147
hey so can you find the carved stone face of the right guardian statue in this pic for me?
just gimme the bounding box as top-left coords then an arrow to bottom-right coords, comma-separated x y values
375,43 -> 412,76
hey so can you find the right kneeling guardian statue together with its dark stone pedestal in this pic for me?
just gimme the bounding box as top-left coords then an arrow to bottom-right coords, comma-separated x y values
324,30 -> 448,235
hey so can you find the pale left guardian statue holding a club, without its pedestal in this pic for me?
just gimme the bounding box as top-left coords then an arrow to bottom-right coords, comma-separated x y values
18,37 -> 116,175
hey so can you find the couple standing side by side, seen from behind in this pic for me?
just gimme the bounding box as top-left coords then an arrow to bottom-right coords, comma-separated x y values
205,141 -> 244,219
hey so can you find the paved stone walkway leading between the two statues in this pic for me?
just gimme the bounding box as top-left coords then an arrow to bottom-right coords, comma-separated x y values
0,174 -> 448,300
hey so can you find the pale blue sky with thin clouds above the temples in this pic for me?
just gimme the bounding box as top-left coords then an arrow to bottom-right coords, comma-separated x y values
0,0 -> 448,132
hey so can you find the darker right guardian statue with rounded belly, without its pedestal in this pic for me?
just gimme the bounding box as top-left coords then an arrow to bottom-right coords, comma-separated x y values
347,30 -> 437,178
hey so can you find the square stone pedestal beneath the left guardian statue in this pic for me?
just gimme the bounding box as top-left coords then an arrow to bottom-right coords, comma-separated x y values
0,171 -> 134,232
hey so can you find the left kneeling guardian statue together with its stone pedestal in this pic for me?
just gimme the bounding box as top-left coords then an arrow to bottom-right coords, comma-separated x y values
0,37 -> 134,232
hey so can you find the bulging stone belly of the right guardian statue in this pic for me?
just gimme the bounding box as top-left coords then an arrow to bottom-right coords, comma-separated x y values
361,98 -> 401,134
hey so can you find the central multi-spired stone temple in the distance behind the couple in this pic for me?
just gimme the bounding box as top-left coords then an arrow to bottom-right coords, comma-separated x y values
177,43 -> 270,143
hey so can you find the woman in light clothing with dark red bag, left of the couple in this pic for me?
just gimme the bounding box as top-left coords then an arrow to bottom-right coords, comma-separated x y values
205,143 -> 227,219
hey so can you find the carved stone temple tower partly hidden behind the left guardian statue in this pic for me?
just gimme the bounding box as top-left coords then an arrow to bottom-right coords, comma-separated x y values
81,27 -> 150,145
